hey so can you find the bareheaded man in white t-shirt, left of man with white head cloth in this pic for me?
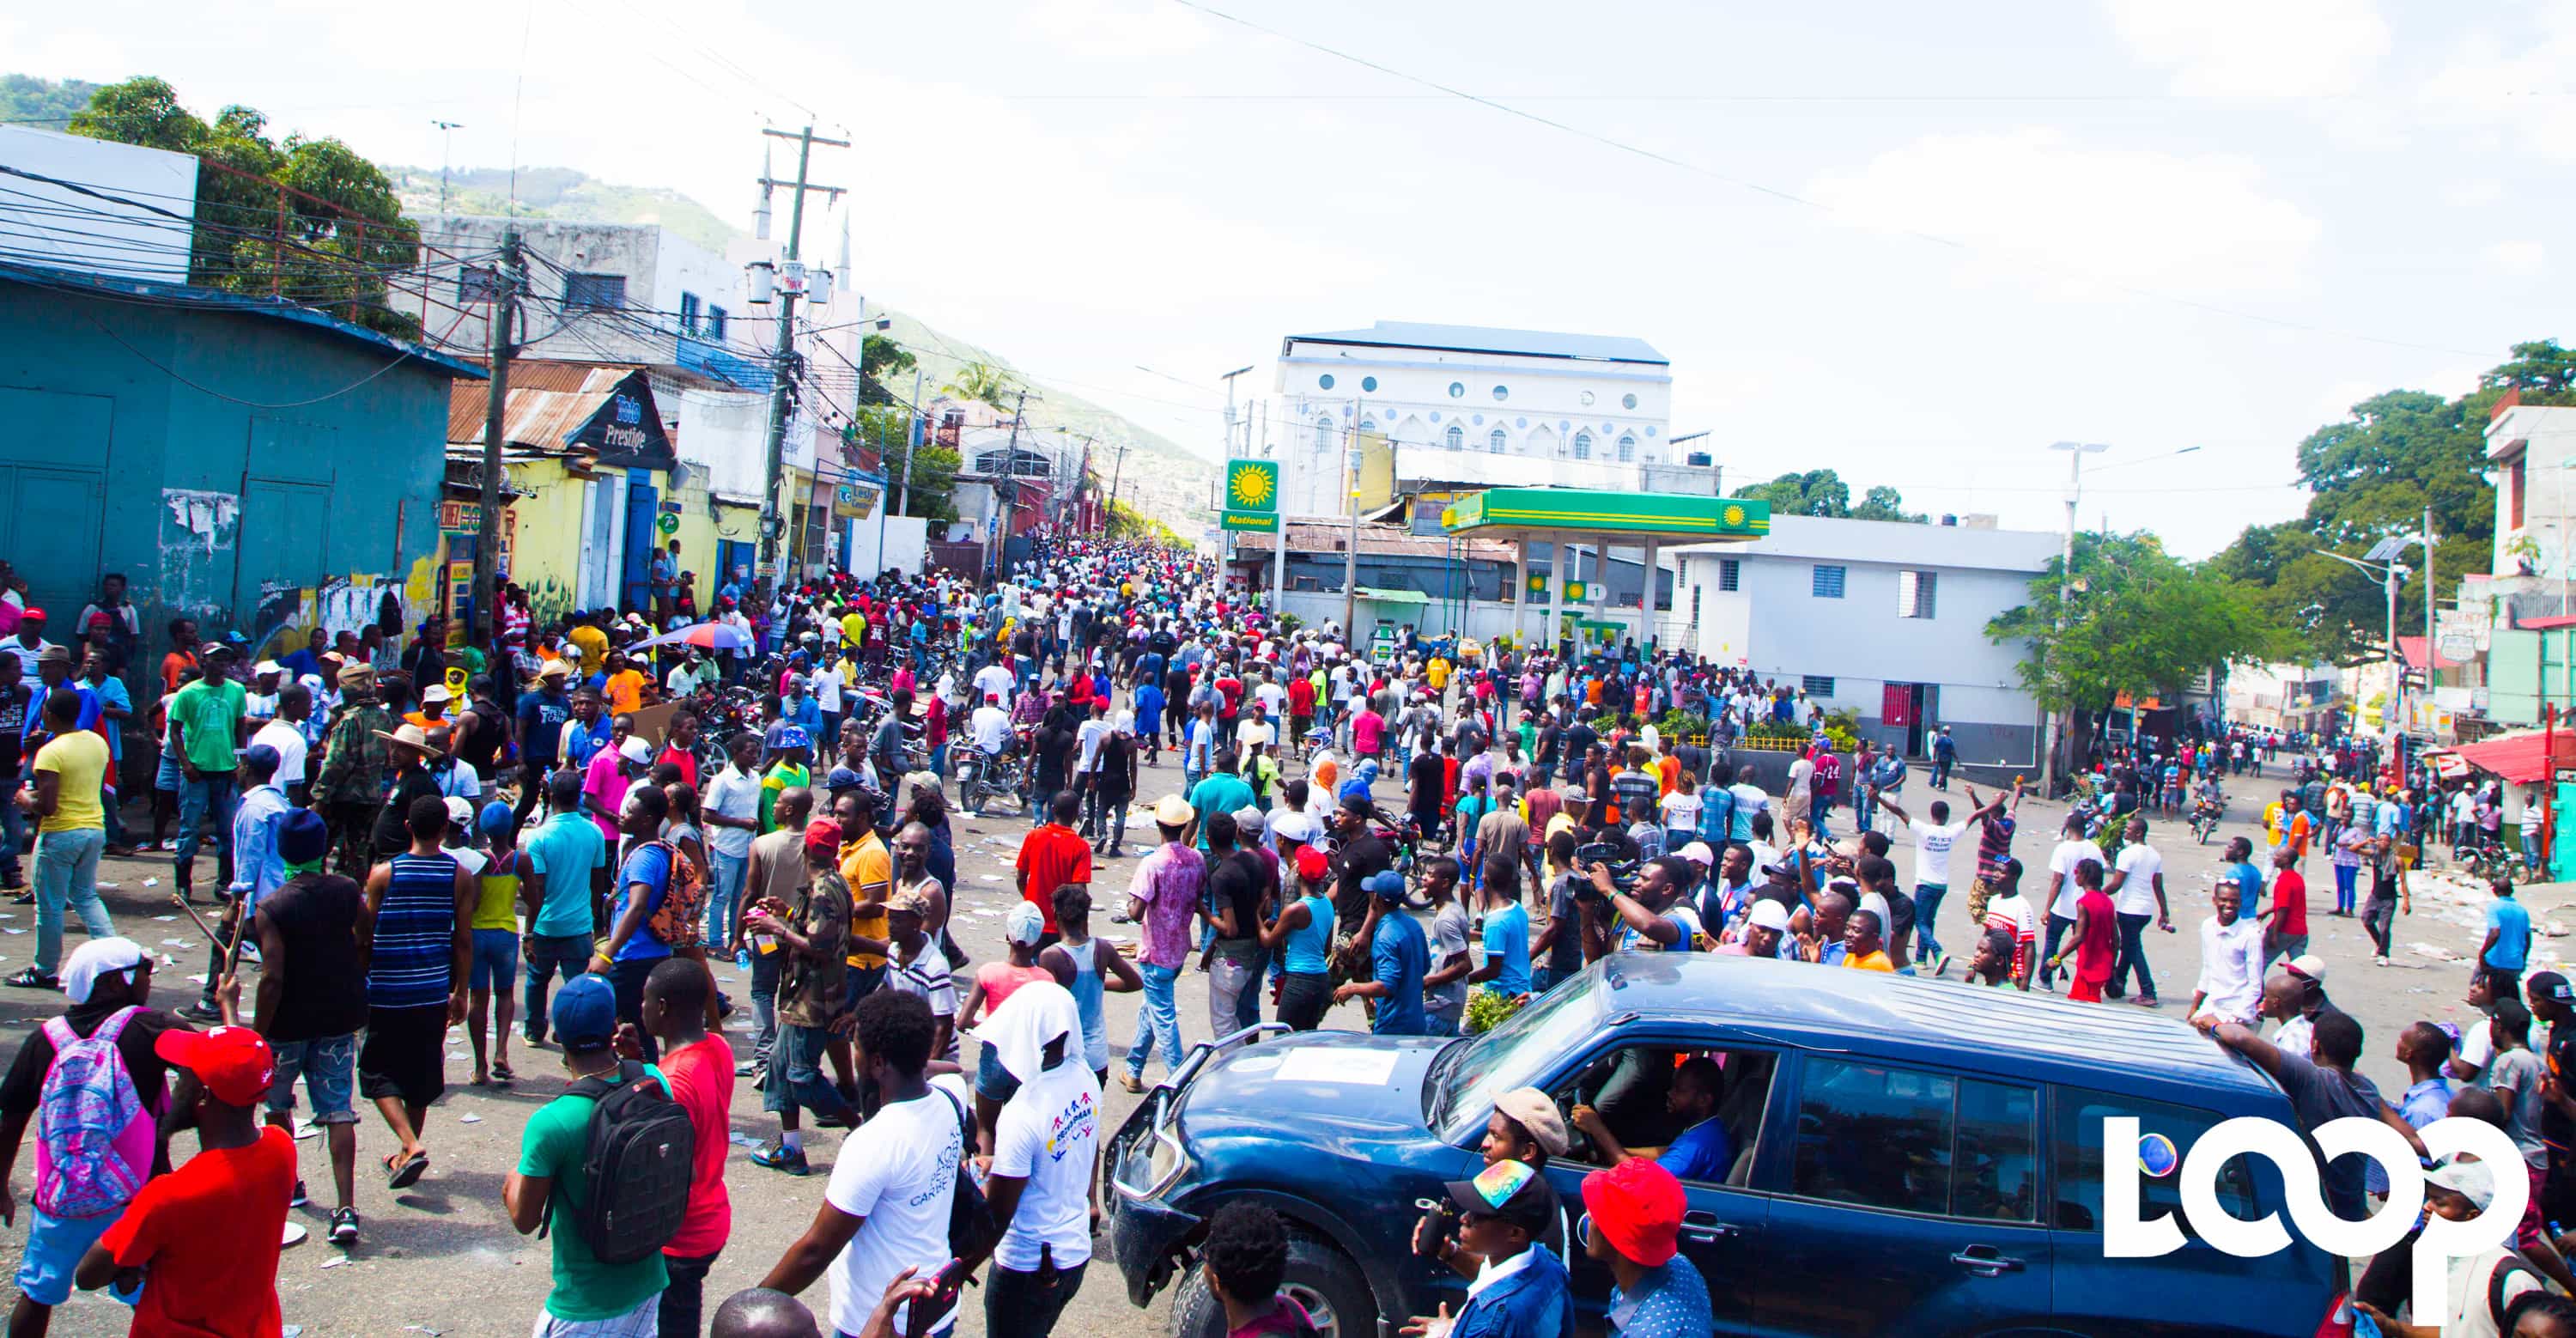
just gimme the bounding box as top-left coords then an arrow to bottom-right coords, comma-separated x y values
760,990 -> 966,1333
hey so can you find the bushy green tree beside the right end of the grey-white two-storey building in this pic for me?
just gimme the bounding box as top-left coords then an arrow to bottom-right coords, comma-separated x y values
1986,531 -> 2290,712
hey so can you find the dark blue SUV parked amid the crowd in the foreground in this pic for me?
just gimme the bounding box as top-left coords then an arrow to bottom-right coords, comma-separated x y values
1103,954 -> 2349,1338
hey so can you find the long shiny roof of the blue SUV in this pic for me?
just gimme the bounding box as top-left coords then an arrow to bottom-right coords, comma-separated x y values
1595,954 -> 2280,1101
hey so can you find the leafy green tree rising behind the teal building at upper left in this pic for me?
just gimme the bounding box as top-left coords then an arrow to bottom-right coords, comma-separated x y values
70,75 -> 420,338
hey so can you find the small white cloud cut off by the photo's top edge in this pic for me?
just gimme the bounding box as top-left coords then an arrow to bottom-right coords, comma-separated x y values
2110,0 -> 2388,98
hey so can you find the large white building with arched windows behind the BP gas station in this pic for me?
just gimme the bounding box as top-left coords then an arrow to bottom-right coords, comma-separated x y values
1267,319 -> 1708,515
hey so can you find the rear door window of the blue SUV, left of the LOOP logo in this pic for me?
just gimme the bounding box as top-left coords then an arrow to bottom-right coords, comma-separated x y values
1790,1060 -> 2040,1222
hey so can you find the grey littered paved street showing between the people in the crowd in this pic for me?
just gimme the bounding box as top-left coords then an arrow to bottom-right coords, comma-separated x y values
0,756 -> 2576,1335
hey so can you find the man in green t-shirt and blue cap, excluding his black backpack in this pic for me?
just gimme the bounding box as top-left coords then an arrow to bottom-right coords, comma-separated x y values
500,975 -> 670,1333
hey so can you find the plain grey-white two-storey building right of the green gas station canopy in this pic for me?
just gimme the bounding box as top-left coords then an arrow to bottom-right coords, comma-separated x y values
1664,515 -> 2058,774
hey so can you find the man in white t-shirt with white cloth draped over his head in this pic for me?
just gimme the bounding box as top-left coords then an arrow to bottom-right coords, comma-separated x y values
969,980 -> 1100,1333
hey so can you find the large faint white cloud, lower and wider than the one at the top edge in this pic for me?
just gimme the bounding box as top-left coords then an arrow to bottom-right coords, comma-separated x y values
1808,129 -> 2321,296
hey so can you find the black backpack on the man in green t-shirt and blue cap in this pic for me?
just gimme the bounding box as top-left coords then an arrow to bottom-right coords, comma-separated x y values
564,1060 -> 698,1263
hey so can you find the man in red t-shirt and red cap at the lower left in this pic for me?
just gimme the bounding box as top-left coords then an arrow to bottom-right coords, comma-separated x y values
72,1010 -> 296,1338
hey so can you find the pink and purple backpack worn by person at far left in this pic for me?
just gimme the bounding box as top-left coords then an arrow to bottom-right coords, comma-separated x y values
36,1006 -> 144,1217
